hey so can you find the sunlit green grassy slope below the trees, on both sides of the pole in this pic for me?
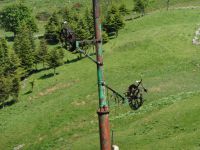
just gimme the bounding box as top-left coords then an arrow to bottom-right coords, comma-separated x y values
0,3 -> 200,150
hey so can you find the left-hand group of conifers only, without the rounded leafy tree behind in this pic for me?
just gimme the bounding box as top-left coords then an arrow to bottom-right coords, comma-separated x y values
0,26 -> 64,105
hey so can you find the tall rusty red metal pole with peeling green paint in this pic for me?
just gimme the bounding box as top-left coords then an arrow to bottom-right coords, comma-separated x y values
93,0 -> 111,150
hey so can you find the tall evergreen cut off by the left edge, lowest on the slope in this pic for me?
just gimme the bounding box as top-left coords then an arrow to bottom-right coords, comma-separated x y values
0,39 -> 19,104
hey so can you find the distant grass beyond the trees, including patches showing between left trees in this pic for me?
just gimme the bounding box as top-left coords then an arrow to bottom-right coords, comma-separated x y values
0,0 -> 200,37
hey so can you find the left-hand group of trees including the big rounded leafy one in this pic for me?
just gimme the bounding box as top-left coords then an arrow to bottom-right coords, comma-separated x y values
0,4 -> 64,106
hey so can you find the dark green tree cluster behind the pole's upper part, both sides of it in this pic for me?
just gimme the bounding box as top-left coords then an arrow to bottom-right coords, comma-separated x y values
44,5 -> 128,44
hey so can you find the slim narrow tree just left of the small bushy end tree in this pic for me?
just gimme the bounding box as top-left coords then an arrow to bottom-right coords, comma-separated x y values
38,39 -> 48,68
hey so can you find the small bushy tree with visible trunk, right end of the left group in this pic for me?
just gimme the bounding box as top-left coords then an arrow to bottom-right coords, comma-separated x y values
47,49 -> 62,75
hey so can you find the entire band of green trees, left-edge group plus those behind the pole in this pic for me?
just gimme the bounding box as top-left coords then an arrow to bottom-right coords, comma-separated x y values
0,0 -> 147,105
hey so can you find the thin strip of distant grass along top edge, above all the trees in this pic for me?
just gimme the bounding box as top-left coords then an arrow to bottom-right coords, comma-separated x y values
0,0 -> 200,14
